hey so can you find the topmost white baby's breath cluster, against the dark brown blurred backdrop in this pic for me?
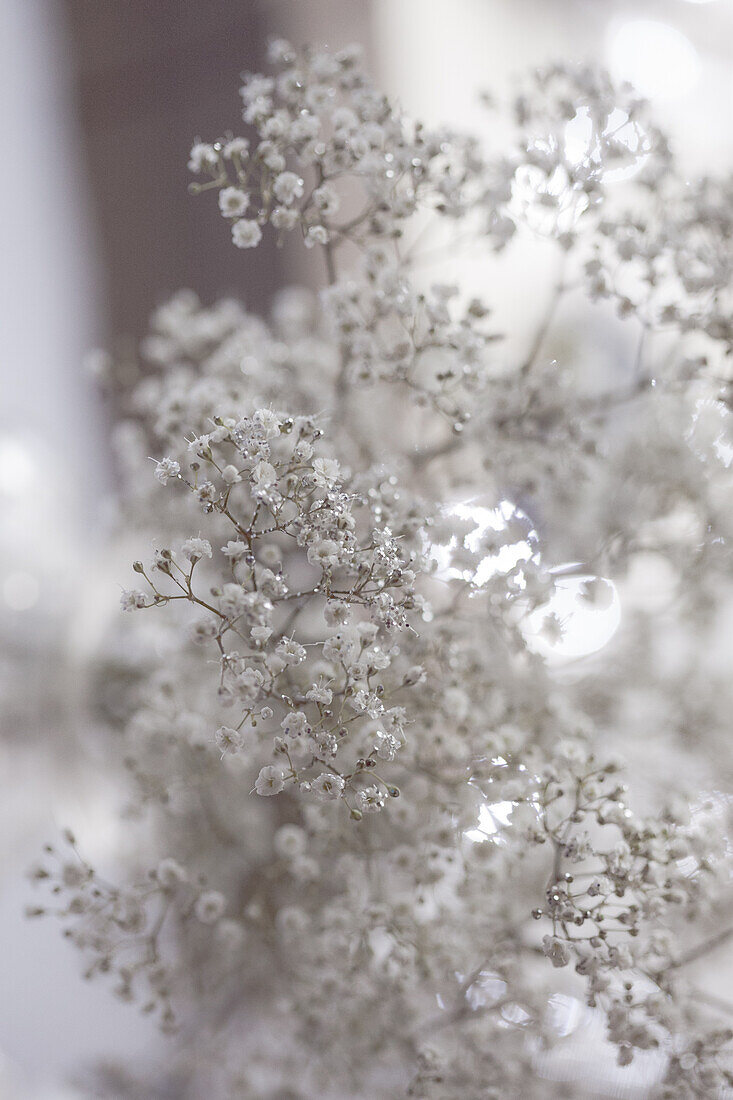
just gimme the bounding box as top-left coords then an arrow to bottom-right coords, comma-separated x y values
188,41 -> 511,255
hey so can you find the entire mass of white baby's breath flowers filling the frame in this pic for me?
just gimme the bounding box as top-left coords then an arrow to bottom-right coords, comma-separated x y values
36,42 -> 733,1100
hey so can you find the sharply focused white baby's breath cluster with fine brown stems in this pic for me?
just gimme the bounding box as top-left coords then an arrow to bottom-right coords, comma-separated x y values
122,408 -> 425,817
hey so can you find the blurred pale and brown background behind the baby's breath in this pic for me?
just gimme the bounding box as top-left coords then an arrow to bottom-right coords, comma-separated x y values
0,0 -> 733,1100
